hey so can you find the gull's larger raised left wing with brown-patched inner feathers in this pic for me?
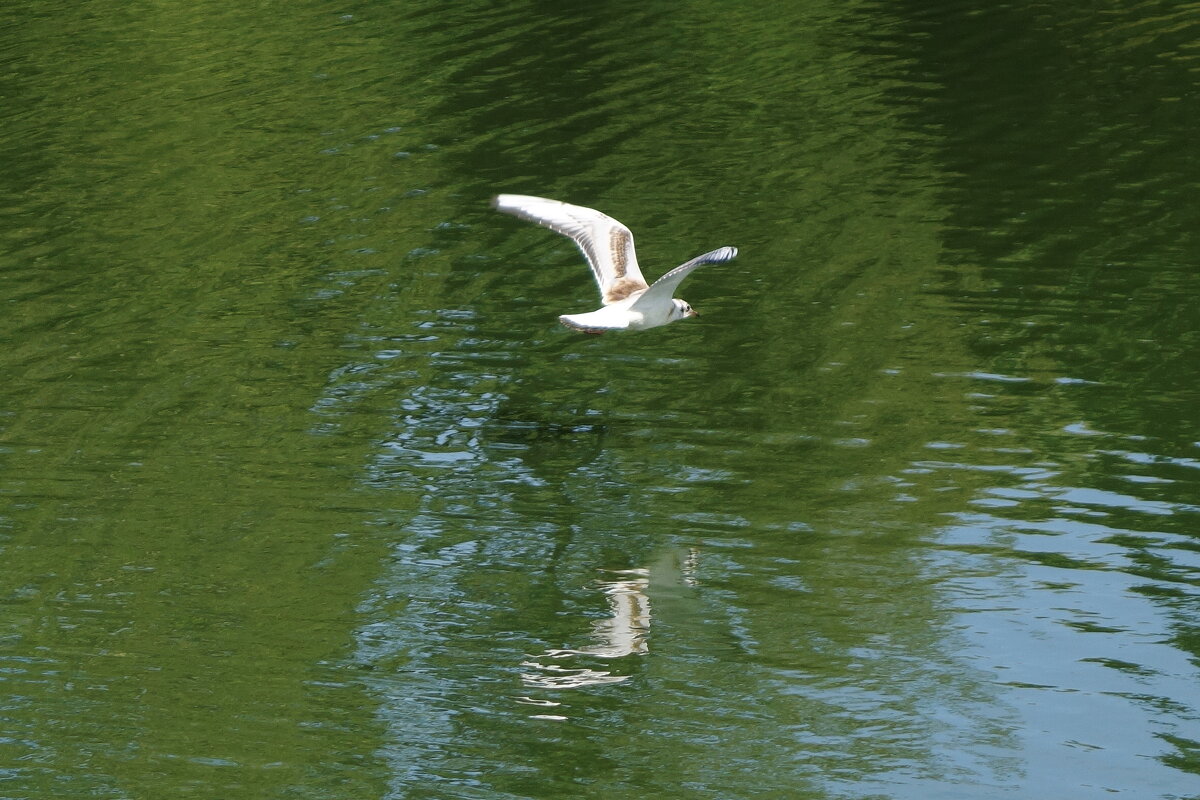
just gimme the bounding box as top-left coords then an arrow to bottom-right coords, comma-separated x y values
492,194 -> 652,306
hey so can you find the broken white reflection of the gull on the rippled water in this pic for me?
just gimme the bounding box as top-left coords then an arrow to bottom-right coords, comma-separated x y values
521,570 -> 650,695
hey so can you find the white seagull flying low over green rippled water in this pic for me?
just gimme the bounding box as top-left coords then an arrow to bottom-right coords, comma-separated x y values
492,194 -> 738,333
